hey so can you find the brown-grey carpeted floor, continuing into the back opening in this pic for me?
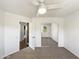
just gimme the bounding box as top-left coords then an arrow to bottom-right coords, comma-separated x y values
4,38 -> 79,59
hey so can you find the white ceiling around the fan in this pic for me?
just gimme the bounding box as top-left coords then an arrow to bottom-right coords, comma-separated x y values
0,0 -> 79,17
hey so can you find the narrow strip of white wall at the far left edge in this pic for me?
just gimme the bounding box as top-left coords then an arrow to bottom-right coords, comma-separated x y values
0,10 -> 4,58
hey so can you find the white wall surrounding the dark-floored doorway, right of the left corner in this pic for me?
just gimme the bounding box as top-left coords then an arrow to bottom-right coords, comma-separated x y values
5,12 -> 35,56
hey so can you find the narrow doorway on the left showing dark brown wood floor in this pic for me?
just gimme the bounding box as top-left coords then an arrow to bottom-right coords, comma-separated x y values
20,22 -> 29,50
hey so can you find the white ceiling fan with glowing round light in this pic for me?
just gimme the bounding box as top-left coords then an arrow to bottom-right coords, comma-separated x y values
32,0 -> 60,14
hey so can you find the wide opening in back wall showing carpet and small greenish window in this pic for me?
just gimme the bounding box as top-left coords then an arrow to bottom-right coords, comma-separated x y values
41,23 -> 58,47
